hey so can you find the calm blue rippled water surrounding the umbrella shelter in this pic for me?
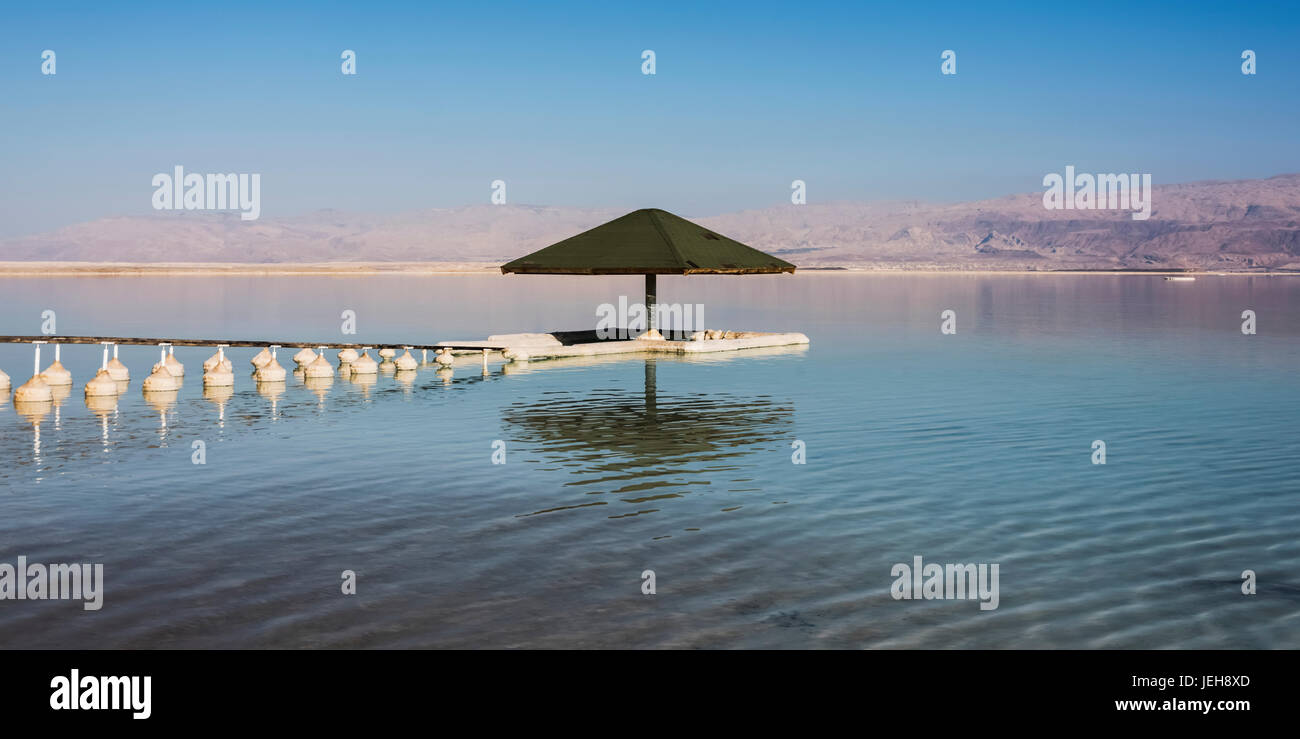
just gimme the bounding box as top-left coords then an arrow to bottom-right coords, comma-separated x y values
0,273 -> 1300,648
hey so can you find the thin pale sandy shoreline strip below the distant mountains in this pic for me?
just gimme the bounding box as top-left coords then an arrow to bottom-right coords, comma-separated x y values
0,262 -> 1300,277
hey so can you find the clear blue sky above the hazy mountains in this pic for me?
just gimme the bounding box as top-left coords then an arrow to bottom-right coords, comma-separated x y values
0,0 -> 1300,235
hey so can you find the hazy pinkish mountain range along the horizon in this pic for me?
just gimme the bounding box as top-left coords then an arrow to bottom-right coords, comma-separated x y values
0,174 -> 1300,271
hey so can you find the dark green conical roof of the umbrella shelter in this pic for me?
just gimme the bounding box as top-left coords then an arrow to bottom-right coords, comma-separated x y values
501,208 -> 794,275
